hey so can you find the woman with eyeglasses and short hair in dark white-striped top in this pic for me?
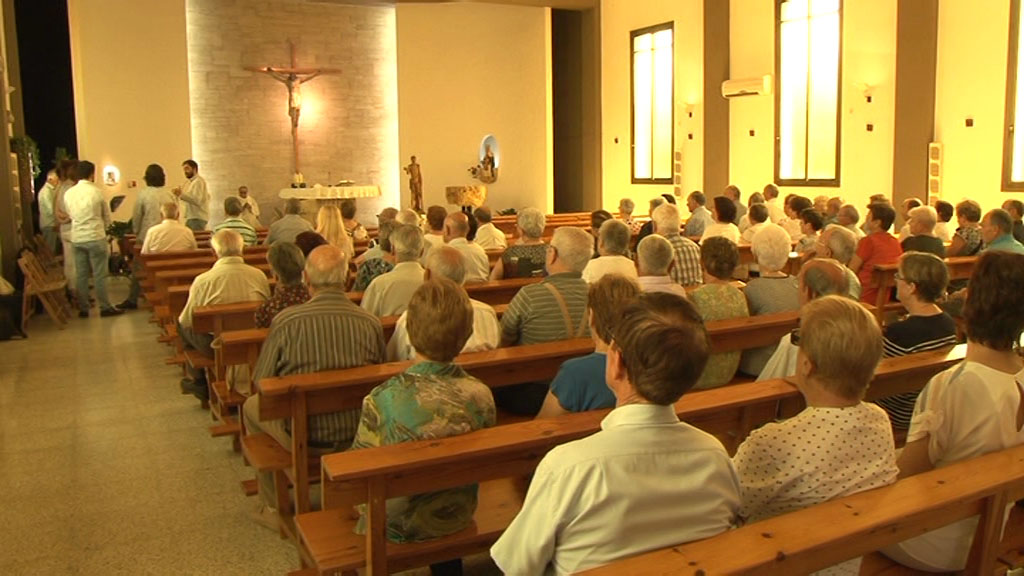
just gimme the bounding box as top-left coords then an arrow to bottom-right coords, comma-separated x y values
878,249 -> 956,429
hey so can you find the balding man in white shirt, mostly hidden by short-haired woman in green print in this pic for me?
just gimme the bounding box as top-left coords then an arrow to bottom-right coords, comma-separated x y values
387,246 -> 502,362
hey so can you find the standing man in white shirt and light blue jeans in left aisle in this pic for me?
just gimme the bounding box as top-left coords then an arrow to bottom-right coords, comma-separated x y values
65,160 -> 124,318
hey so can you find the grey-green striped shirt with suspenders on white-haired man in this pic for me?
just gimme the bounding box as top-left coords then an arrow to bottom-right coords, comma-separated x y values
502,273 -> 590,345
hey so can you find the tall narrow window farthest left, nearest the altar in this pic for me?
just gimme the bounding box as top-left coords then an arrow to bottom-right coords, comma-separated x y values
630,22 -> 675,183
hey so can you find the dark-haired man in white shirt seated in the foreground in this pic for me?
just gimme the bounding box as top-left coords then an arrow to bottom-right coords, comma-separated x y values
490,292 -> 739,574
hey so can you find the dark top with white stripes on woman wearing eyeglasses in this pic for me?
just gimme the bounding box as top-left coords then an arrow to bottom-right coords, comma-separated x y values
878,313 -> 956,429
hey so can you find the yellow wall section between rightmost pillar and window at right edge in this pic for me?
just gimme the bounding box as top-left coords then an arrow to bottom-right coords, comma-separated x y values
935,0 -> 1024,210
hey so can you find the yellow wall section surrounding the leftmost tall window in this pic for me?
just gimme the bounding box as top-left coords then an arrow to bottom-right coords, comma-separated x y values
601,0 -> 703,215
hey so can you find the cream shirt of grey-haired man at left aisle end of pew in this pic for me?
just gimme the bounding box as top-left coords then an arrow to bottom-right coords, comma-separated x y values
178,256 -> 270,327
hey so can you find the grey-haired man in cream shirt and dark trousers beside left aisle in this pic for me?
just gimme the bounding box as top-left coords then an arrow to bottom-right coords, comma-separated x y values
178,230 -> 270,400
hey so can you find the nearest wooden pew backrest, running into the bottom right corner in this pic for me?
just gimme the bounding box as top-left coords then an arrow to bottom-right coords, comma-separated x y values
586,445 -> 1024,576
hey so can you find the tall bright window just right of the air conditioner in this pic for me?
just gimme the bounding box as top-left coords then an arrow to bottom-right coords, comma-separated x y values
775,0 -> 843,187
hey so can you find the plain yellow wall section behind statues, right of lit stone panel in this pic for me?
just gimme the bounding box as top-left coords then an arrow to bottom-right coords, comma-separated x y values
396,4 -> 554,212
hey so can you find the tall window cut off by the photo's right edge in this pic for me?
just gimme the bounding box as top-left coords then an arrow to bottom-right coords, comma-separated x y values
1002,0 -> 1024,190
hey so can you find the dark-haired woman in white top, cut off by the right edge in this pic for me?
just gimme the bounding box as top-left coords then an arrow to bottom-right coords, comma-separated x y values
883,252 -> 1024,572
